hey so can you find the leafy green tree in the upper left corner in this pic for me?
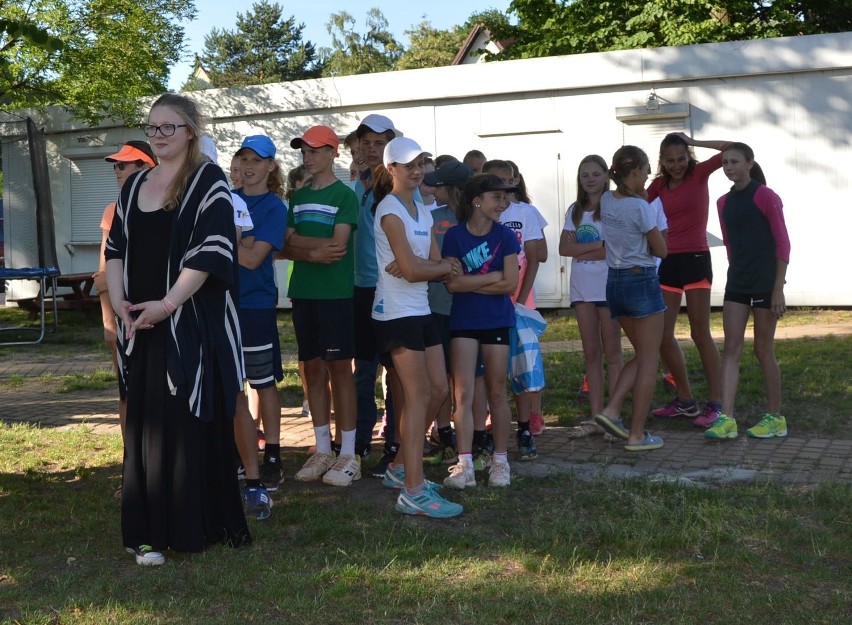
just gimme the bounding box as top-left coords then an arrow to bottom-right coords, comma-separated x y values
0,0 -> 195,124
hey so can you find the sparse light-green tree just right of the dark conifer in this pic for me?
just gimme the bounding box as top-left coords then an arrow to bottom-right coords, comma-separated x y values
322,8 -> 403,76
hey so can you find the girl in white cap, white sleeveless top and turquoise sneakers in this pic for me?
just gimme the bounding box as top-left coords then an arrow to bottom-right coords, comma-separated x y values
372,137 -> 463,518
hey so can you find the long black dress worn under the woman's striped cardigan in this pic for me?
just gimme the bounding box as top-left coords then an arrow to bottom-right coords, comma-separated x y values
121,197 -> 251,551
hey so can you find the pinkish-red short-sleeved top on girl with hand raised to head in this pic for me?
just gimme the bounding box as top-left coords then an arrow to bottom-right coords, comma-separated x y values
648,152 -> 722,254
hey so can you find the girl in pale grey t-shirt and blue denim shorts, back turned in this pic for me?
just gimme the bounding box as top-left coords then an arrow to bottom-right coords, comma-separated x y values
595,145 -> 668,451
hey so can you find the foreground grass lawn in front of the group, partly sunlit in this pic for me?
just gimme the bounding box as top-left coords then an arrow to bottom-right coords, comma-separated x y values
0,426 -> 852,625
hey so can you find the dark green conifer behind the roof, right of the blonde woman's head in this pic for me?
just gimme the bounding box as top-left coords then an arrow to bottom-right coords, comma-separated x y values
200,0 -> 322,87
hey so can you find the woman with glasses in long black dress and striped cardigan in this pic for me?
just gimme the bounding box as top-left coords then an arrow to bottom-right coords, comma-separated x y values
105,94 -> 251,565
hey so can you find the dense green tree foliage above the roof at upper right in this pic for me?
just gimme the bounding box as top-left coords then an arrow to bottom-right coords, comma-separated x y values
492,0 -> 852,59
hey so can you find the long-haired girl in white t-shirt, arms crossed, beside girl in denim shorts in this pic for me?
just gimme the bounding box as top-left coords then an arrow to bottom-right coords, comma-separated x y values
559,154 -> 624,422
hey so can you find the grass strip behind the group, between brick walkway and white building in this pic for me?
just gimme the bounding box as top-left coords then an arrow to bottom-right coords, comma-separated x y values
0,309 -> 852,437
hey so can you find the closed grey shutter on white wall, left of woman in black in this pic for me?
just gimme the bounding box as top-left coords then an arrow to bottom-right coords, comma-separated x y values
71,157 -> 118,243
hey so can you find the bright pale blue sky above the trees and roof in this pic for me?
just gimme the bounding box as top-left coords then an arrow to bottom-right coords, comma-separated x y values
169,0 -> 510,91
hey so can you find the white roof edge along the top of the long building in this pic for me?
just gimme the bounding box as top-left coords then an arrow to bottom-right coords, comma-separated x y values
8,32 -> 852,135
